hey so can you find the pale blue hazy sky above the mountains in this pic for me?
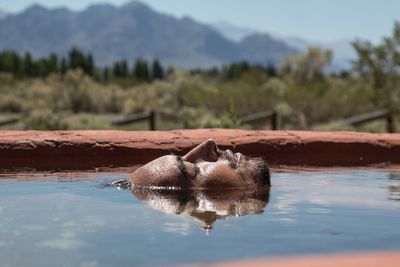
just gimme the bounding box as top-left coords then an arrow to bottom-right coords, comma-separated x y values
0,0 -> 400,41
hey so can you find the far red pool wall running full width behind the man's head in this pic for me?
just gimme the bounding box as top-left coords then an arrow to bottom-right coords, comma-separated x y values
0,129 -> 400,170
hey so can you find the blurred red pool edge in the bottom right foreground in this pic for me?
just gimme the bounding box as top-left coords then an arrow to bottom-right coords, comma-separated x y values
181,251 -> 400,267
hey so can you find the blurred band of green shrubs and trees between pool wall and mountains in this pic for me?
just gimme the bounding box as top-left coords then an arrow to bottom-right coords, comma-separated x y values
0,23 -> 400,132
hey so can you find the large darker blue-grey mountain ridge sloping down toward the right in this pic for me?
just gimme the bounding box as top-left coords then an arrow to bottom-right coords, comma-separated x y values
0,1 -> 298,68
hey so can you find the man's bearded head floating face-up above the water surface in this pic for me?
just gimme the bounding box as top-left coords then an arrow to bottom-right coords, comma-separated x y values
129,139 -> 270,189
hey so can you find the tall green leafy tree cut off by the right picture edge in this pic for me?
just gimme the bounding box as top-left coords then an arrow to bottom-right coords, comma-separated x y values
353,22 -> 400,114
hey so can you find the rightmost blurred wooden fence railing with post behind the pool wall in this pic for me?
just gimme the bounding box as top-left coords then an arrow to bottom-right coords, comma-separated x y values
344,110 -> 396,133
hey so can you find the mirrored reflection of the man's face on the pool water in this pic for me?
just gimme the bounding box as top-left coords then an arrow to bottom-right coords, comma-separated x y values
132,188 -> 269,232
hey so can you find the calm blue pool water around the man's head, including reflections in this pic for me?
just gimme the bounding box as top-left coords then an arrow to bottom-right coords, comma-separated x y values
0,170 -> 400,266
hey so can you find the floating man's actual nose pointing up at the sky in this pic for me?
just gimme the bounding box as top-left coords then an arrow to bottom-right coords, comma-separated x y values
183,139 -> 218,163
